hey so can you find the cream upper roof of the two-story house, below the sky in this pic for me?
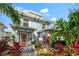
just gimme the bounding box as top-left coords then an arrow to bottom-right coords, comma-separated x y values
17,10 -> 51,24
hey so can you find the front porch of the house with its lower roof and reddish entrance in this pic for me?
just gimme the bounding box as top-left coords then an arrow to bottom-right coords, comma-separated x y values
12,25 -> 36,42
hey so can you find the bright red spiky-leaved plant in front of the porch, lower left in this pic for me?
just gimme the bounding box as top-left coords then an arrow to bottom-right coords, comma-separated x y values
10,42 -> 21,56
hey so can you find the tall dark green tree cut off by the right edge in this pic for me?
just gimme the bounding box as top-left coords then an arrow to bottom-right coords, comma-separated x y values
68,9 -> 79,39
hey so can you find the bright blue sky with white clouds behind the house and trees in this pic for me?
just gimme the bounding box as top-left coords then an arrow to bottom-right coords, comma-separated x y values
0,3 -> 76,31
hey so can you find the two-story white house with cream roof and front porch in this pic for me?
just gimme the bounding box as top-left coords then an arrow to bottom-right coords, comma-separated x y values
11,10 -> 50,41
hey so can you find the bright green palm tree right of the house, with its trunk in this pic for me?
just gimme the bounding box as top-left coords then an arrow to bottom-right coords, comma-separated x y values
52,18 -> 72,55
